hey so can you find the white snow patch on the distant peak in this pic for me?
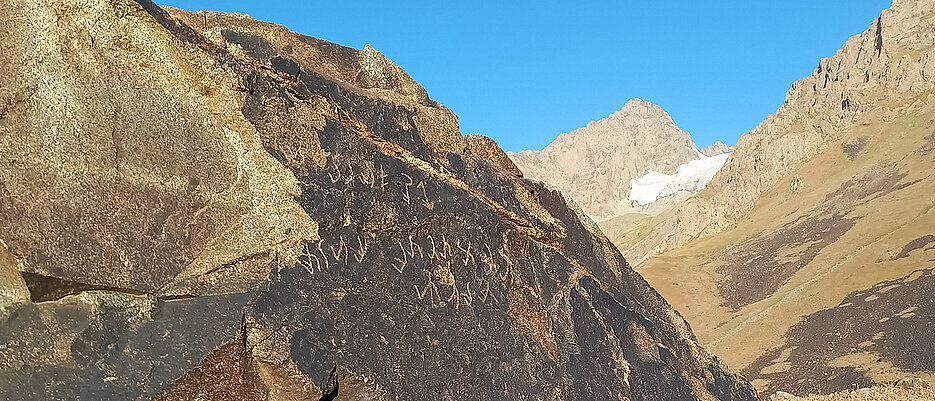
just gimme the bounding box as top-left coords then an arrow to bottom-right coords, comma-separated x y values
627,152 -> 730,206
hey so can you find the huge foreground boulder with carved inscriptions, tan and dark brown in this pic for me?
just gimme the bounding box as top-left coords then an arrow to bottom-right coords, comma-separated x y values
0,0 -> 756,400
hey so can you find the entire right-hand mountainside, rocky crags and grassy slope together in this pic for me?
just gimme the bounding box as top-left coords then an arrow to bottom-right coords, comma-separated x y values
620,0 -> 935,394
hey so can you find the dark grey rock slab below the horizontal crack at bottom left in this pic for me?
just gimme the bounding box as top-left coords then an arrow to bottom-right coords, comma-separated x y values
0,292 -> 253,400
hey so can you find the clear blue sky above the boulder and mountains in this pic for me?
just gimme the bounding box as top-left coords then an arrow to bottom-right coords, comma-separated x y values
157,0 -> 890,151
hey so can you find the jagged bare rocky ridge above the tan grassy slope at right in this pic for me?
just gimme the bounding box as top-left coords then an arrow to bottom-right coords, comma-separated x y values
616,0 -> 935,264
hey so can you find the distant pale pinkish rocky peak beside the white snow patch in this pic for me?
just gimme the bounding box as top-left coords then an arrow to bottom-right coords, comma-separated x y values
507,99 -> 699,221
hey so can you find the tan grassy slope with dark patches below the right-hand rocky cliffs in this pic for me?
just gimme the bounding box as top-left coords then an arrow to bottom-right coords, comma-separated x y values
639,101 -> 935,392
